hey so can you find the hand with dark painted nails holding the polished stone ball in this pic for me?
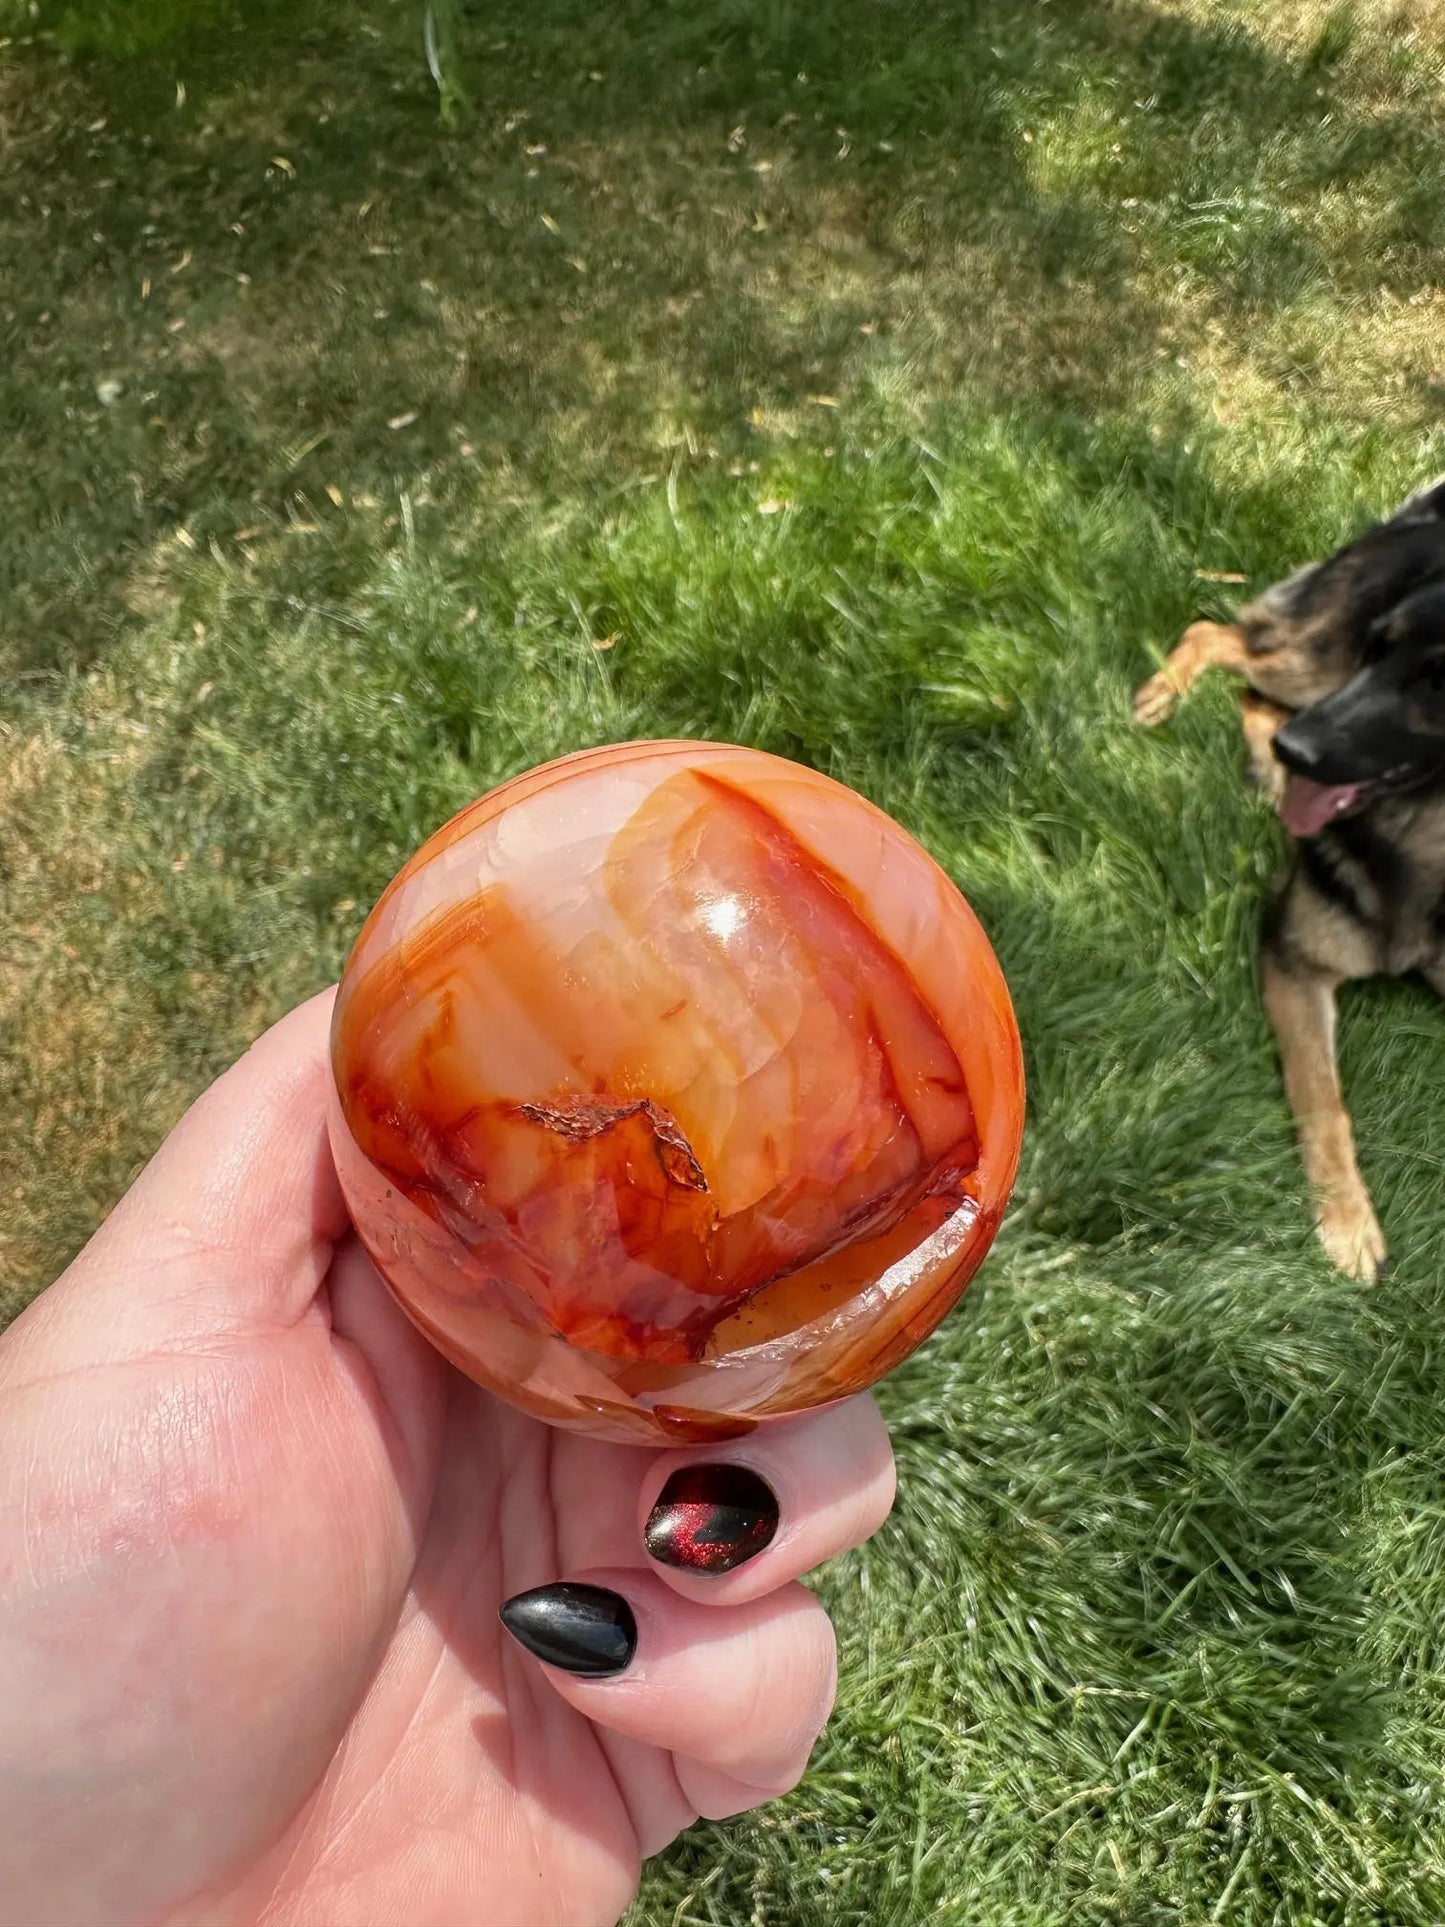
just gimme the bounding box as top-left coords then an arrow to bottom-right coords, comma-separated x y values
0,994 -> 894,1927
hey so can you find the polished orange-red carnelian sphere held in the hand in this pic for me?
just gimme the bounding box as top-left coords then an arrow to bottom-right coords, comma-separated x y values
331,742 -> 1023,1443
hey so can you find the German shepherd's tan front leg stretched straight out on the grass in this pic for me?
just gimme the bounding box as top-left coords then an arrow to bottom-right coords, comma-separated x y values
1264,948 -> 1385,1283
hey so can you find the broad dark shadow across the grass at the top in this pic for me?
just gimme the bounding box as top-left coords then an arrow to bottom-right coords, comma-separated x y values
0,0 -> 1445,673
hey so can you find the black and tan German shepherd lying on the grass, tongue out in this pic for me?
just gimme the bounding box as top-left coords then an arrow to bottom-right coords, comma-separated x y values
1135,478 -> 1445,1280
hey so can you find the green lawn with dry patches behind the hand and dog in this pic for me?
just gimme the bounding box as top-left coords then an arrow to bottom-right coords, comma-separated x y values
0,0 -> 1445,1927
